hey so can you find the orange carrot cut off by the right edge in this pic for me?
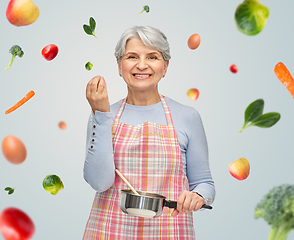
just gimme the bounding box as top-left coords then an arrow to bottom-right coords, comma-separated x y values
274,62 -> 294,98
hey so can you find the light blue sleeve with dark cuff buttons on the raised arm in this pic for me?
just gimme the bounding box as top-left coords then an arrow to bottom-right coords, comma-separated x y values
83,111 -> 115,192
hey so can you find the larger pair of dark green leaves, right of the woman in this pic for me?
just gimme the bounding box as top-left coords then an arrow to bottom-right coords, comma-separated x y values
239,99 -> 281,132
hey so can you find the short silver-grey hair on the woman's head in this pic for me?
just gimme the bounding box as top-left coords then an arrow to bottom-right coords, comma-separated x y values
114,26 -> 171,61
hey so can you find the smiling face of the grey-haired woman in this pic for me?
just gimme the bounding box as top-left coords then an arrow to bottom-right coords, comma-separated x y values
118,38 -> 169,93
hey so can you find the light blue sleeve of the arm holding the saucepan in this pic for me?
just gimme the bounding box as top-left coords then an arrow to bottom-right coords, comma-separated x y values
186,109 -> 215,204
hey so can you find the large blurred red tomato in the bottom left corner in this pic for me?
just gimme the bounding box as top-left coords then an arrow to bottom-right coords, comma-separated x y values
0,207 -> 35,240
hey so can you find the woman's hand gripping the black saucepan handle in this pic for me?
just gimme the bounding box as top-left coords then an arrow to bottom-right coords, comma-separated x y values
171,190 -> 205,217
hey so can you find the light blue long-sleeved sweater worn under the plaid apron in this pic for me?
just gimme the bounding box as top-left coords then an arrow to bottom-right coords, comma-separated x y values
84,97 -> 215,204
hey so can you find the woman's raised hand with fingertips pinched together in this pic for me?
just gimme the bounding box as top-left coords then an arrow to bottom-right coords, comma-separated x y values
86,76 -> 110,114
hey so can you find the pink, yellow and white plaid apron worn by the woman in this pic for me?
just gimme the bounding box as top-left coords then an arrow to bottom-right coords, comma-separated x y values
83,96 -> 195,240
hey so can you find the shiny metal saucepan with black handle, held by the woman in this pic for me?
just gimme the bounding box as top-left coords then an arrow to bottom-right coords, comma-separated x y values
120,190 -> 212,218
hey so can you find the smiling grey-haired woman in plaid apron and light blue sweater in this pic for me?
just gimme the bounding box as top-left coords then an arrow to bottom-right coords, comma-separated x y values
83,26 -> 215,240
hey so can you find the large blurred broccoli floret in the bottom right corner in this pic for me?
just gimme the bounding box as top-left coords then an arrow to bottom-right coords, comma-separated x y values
255,184 -> 294,240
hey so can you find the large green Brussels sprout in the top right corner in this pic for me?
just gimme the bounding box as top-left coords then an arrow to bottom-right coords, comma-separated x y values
235,0 -> 269,36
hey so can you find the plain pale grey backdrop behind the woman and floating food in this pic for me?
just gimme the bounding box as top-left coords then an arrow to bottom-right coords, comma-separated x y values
0,0 -> 294,240
